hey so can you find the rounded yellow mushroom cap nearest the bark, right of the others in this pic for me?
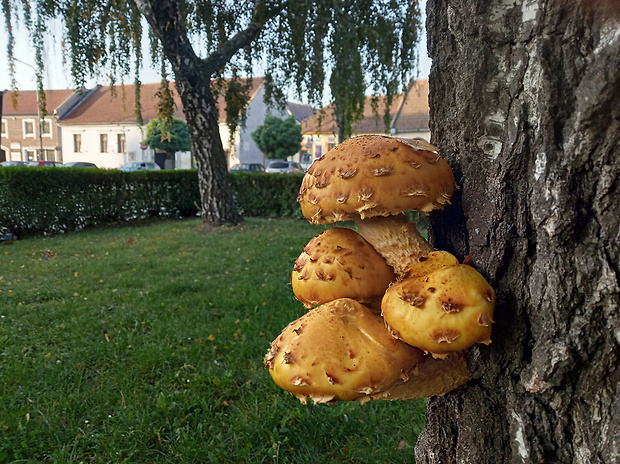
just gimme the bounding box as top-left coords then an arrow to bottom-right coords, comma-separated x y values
381,251 -> 495,356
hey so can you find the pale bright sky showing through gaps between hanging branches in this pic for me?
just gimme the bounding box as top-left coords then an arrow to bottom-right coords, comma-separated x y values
0,0 -> 431,100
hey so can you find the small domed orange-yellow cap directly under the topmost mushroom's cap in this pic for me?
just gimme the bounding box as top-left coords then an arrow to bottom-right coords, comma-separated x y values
291,227 -> 395,309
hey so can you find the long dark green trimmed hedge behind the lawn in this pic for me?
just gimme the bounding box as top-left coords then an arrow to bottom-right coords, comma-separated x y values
0,167 -> 303,236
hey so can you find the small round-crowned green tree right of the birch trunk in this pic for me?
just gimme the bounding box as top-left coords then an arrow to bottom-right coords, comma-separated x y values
252,115 -> 303,159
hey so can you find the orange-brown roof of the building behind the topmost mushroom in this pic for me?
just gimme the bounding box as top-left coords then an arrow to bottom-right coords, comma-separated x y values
301,79 -> 429,134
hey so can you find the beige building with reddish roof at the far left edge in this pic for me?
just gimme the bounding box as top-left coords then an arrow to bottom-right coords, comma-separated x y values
0,90 -> 84,162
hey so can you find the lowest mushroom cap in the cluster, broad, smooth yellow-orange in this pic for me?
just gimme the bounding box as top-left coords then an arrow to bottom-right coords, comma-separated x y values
265,298 -> 425,403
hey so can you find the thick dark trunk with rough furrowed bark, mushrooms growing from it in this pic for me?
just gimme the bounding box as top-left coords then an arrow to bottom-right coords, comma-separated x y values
416,0 -> 620,464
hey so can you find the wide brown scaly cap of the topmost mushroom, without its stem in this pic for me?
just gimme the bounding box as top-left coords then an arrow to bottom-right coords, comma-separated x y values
298,135 -> 455,224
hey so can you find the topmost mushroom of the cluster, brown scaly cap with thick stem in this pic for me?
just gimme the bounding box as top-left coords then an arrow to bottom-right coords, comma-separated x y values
298,135 -> 455,275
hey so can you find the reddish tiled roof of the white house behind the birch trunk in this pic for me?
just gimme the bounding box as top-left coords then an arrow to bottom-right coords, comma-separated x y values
61,78 -> 263,124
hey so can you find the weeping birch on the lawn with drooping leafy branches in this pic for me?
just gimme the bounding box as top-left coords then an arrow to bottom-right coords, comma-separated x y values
2,0 -> 420,225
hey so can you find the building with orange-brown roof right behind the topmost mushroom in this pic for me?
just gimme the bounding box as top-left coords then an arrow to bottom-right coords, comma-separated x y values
295,79 -> 431,166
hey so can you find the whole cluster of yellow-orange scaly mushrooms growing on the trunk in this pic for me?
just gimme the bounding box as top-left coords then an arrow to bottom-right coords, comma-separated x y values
264,135 -> 495,403
